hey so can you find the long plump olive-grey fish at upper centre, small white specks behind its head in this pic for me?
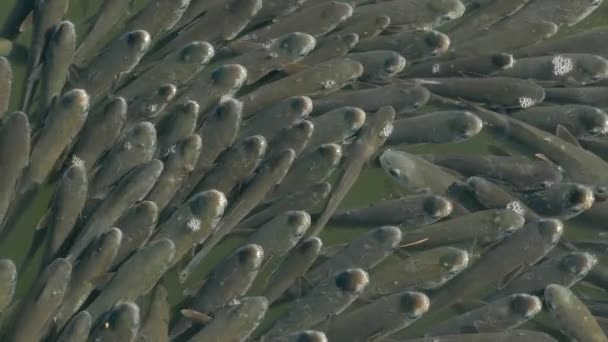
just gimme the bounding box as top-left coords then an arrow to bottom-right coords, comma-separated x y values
239,58 -> 363,113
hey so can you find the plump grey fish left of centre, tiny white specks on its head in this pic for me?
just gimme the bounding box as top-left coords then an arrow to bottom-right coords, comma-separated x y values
89,121 -> 157,198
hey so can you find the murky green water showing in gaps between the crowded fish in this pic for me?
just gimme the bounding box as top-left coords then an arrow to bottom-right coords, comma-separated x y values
0,0 -> 608,340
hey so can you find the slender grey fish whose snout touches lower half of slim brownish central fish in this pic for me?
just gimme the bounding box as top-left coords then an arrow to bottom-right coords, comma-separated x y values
237,182 -> 331,229
